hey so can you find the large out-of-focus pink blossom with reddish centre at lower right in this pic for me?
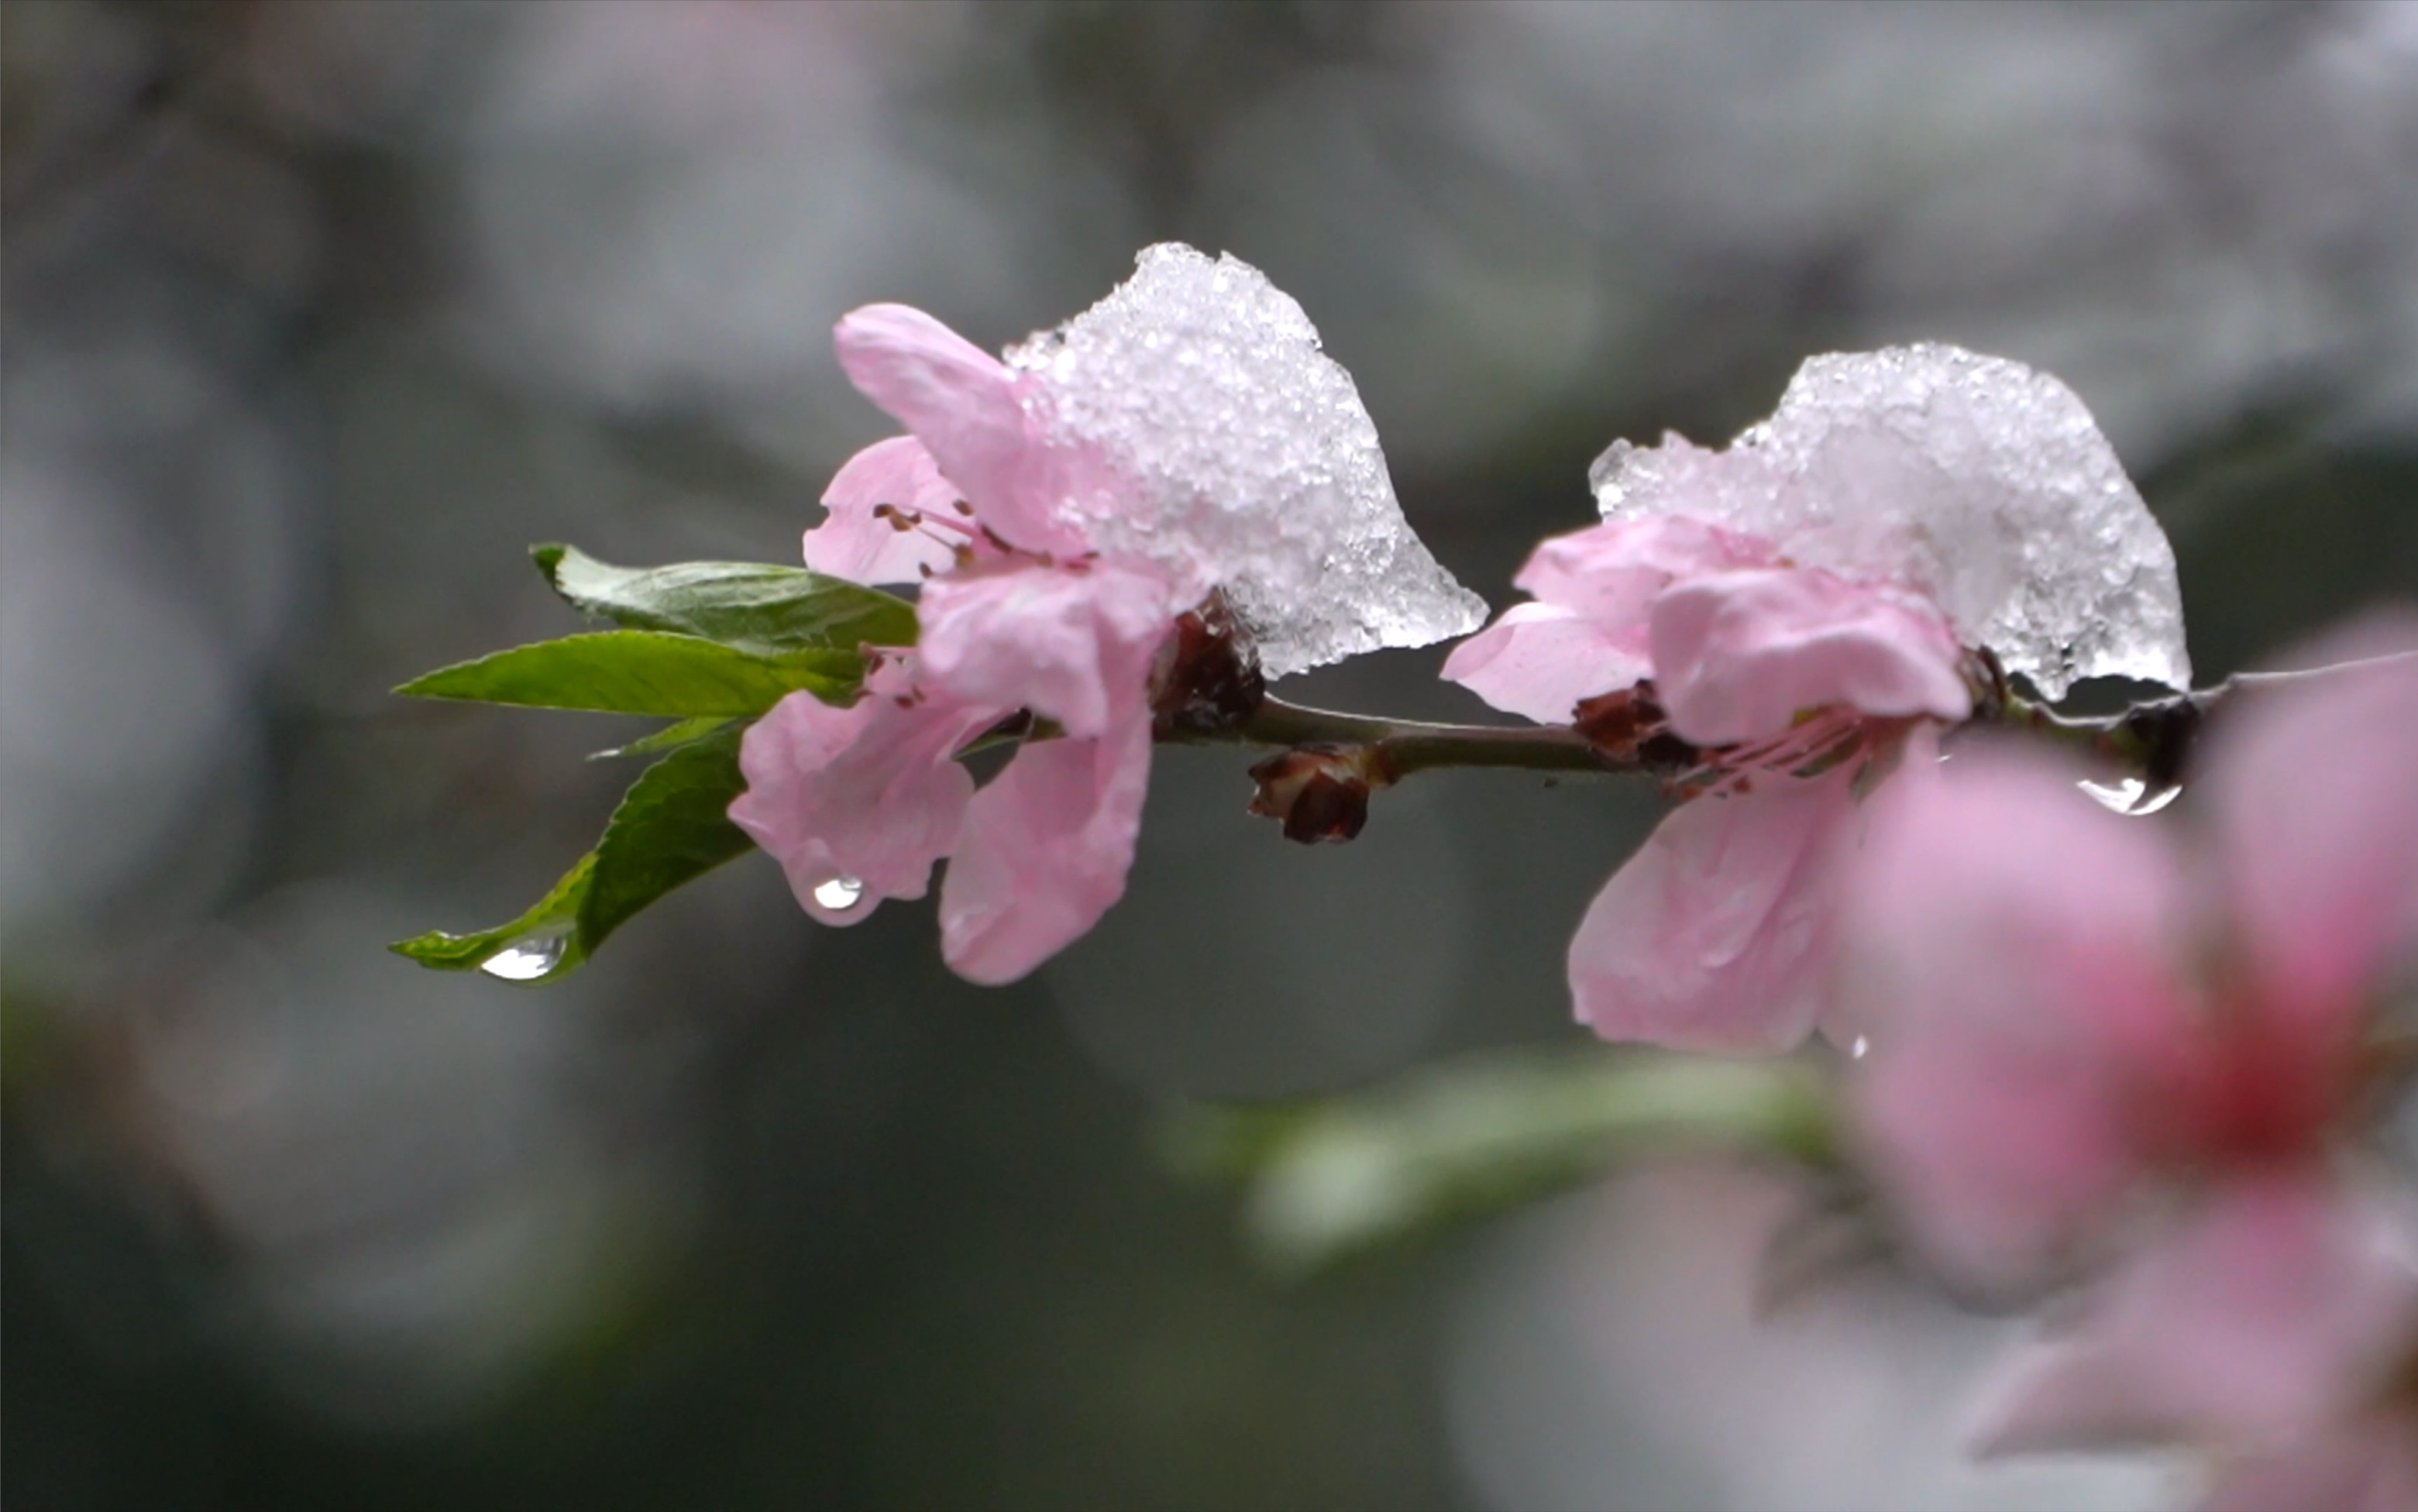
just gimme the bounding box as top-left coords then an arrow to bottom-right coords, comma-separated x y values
1838,636 -> 2418,1461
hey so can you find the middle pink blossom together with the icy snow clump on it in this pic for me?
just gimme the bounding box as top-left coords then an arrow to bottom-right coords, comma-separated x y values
1443,346 -> 2191,1050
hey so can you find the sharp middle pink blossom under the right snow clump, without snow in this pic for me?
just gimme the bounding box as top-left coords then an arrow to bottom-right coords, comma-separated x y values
1443,513 -> 1973,1053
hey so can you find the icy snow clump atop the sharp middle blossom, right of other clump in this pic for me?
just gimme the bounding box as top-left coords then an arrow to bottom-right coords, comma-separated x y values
1588,343 -> 2191,699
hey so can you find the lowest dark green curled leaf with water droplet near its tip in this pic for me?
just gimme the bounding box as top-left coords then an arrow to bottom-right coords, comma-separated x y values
392,730 -> 752,985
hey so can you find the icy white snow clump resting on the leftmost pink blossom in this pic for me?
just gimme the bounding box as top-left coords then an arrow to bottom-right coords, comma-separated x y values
1008,242 -> 1487,677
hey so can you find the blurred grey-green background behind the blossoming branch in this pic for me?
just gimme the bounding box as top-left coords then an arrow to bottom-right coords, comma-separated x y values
0,0 -> 2418,1512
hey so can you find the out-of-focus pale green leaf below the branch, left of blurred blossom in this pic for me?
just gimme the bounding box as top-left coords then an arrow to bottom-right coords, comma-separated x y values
1168,1050 -> 1835,1275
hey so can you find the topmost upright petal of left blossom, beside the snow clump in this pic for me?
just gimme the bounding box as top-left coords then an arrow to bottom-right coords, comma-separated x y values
834,305 -> 1083,554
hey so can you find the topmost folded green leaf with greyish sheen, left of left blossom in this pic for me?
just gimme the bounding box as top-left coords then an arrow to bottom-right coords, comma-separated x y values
529,545 -> 917,653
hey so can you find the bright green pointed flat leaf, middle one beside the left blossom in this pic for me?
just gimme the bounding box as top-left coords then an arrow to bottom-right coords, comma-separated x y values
394,629 -> 863,719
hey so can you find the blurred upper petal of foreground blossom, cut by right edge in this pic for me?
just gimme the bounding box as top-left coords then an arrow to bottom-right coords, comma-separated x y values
2200,620 -> 2418,1043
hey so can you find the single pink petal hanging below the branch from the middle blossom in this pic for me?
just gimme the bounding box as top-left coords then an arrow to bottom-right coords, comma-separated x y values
1570,774 -> 1855,1055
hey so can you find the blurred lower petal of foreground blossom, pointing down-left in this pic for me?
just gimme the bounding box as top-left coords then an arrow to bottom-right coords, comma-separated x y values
1980,1169 -> 2418,1454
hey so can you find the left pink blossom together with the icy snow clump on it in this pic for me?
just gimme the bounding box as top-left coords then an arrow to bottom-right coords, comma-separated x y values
731,244 -> 1484,982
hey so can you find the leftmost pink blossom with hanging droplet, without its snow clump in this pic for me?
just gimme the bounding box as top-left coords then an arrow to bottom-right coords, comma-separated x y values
731,305 -> 1199,982
